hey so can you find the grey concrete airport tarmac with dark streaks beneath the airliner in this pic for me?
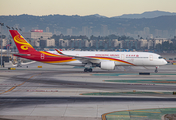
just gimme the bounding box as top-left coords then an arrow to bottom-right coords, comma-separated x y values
0,62 -> 176,120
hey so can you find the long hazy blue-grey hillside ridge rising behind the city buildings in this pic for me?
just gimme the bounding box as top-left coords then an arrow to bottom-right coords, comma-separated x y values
0,14 -> 176,35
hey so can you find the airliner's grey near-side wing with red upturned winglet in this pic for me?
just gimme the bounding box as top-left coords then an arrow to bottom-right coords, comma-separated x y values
55,49 -> 100,63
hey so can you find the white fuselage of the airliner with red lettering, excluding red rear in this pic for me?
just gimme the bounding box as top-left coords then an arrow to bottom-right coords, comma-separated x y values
48,51 -> 167,66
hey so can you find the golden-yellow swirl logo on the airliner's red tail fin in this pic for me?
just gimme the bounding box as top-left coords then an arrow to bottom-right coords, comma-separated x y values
14,35 -> 33,50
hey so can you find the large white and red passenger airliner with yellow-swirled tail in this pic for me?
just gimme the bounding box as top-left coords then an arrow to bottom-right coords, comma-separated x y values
9,30 -> 167,72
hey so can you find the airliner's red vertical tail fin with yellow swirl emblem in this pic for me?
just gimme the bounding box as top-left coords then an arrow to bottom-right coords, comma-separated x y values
9,30 -> 36,54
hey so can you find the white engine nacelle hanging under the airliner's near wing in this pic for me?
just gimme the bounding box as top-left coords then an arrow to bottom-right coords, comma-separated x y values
100,61 -> 115,70
